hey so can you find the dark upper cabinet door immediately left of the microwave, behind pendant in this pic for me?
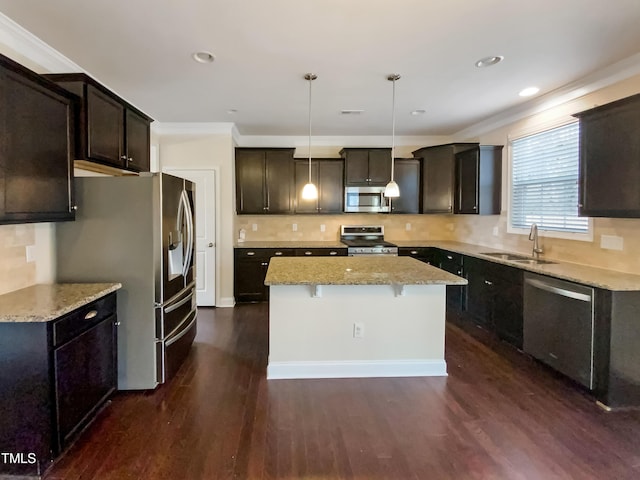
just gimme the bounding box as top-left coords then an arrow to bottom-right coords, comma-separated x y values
295,159 -> 344,213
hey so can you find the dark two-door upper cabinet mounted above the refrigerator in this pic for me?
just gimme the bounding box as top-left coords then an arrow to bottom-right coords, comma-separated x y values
46,73 -> 153,173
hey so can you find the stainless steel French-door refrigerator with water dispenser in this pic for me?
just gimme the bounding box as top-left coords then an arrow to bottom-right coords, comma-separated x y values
56,174 -> 197,390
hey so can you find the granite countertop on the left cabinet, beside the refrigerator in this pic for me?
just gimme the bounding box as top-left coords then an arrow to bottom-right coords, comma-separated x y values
0,283 -> 122,322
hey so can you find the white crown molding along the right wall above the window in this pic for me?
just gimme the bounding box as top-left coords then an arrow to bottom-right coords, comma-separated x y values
453,53 -> 640,139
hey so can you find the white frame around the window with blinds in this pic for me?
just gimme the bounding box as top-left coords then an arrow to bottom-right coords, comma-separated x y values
506,117 -> 594,242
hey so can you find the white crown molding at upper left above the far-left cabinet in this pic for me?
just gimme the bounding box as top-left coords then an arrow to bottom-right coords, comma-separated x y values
0,13 -> 86,73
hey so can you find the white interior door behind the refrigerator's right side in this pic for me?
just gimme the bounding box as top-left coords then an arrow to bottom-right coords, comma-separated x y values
163,168 -> 216,307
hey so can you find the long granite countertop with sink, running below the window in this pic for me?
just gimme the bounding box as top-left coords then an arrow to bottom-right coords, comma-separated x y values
389,240 -> 640,291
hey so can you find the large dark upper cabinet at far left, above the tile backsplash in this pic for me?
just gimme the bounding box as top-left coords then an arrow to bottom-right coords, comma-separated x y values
0,55 -> 77,223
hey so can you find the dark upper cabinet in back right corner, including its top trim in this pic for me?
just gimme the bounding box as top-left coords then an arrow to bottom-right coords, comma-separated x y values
412,143 -> 478,213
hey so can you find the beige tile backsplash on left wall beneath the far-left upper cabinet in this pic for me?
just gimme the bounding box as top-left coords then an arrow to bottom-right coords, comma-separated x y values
0,224 -> 36,294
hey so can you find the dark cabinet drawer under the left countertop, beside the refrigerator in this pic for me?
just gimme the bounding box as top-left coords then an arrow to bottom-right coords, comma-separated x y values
53,293 -> 116,347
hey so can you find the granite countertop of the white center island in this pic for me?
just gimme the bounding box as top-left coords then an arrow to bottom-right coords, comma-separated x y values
264,256 -> 467,285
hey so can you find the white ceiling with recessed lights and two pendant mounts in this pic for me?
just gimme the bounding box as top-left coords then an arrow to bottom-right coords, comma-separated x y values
0,0 -> 640,136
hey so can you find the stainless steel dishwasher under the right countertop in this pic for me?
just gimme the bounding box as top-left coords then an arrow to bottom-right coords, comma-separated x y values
523,272 -> 594,389
